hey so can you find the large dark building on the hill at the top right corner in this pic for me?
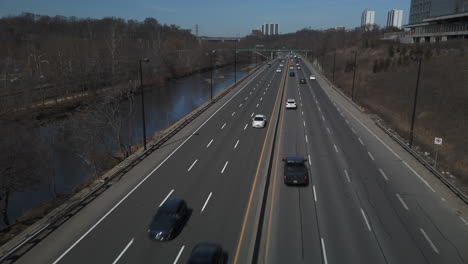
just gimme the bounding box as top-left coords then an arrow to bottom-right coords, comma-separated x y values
403,0 -> 468,43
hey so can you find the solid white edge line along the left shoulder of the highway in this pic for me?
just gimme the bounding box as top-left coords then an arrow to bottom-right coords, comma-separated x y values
52,62 -> 268,264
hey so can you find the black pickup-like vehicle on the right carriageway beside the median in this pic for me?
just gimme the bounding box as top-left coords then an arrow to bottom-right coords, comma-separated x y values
283,156 -> 309,185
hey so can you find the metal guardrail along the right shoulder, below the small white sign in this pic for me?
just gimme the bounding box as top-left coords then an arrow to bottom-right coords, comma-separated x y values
375,120 -> 468,204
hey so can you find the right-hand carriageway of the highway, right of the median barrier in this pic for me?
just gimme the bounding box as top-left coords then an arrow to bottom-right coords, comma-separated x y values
259,58 -> 468,263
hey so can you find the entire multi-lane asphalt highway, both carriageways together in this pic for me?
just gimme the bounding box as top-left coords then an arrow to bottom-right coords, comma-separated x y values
11,54 -> 468,263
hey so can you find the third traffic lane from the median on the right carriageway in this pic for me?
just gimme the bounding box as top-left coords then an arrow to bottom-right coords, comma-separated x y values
298,65 -> 424,263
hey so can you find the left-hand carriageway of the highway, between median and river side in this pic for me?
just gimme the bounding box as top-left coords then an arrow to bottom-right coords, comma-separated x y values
14,58 -> 285,263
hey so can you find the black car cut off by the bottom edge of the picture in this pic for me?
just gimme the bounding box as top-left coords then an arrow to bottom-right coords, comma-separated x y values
187,242 -> 226,264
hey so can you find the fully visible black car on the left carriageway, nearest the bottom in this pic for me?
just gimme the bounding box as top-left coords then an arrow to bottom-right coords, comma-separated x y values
148,198 -> 189,241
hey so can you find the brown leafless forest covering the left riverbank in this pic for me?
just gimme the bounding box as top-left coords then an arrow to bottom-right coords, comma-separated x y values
0,13 -> 251,227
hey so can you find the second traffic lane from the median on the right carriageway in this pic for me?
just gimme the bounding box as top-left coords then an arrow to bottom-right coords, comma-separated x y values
300,71 -> 385,263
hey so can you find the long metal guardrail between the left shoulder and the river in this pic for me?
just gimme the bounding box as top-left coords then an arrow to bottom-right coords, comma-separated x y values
0,64 -> 264,263
